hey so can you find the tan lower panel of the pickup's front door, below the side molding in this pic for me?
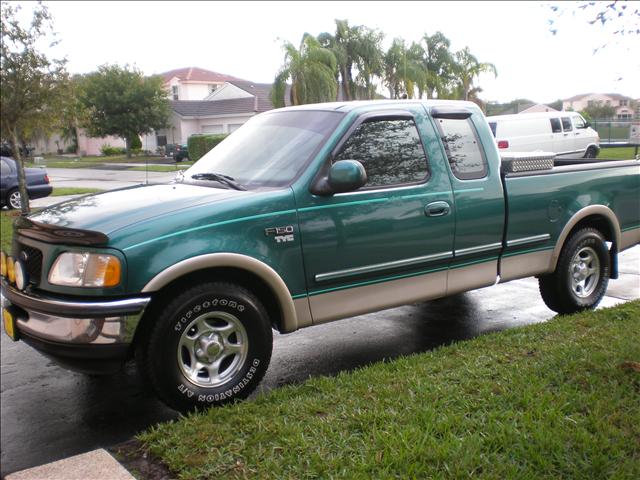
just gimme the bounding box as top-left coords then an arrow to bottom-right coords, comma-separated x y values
308,270 -> 447,324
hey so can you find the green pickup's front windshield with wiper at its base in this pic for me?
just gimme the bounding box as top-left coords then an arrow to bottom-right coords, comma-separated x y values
183,110 -> 344,188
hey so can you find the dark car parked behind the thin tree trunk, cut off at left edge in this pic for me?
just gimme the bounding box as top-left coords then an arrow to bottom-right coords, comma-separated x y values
0,157 -> 53,209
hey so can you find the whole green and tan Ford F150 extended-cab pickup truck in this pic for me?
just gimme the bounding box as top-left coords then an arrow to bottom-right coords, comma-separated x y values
2,100 -> 640,410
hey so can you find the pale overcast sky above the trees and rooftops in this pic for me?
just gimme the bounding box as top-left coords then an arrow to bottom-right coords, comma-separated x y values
11,1 -> 640,103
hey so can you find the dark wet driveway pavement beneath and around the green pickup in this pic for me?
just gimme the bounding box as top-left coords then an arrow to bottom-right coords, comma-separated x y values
0,246 -> 640,476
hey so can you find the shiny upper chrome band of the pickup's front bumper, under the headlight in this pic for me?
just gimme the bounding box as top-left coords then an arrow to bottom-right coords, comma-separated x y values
2,279 -> 151,318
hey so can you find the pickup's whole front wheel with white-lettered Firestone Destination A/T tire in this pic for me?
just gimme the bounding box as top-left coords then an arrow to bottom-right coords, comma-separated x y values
140,282 -> 273,412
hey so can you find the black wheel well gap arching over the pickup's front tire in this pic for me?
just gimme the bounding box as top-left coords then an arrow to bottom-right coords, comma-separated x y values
133,267 -> 282,347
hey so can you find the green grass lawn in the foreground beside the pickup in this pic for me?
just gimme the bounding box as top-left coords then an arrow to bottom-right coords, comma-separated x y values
138,301 -> 640,479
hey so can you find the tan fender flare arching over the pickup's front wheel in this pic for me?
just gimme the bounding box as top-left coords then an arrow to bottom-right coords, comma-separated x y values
142,253 -> 299,333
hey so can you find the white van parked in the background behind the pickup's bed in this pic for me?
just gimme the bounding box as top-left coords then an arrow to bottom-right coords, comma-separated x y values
487,112 -> 600,158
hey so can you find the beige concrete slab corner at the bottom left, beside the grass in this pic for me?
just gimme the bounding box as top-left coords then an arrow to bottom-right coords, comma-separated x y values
5,448 -> 135,480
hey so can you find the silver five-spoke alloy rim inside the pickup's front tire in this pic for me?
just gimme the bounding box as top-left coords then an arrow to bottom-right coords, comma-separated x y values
177,312 -> 249,388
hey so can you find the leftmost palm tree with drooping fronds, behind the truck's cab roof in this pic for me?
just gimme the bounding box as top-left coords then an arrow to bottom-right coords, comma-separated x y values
271,33 -> 338,108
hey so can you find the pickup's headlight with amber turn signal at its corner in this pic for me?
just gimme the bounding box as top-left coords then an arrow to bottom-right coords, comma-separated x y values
49,252 -> 120,287
